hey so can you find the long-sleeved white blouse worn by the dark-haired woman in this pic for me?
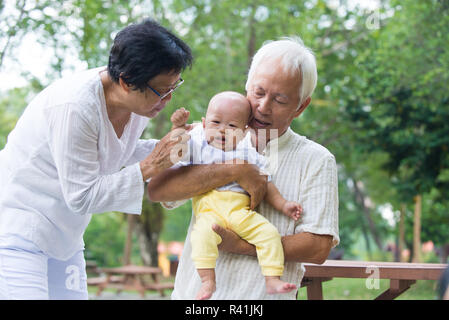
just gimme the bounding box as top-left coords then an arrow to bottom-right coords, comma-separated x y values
0,67 -> 158,260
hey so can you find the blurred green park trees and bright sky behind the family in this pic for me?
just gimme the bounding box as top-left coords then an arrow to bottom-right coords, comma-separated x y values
0,0 -> 449,299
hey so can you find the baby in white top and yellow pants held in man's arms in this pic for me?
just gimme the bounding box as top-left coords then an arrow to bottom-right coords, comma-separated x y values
171,91 -> 302,300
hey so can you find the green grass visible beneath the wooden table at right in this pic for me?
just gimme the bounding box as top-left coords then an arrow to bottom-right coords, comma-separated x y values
298,278 -> 438,300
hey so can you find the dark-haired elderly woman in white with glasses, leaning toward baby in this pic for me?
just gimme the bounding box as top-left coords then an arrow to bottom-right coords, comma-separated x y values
0,20 -> 192,299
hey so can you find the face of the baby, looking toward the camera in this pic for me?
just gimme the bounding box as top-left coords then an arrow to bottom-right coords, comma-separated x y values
203,96 -> 251,151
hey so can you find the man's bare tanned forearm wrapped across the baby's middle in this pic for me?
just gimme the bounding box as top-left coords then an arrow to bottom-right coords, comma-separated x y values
148,164 -> 244,202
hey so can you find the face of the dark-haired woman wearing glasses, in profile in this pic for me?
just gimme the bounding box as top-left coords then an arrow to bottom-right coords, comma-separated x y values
124,72 -> 181,118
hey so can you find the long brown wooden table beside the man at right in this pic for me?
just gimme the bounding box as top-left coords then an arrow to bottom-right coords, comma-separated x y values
301,260 -> 448,300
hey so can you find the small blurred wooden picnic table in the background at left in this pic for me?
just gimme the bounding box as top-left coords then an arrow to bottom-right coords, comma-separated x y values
97,265 -> 174,298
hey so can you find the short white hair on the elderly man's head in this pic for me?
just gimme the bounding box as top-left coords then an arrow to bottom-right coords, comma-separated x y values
245,36 -> 318,108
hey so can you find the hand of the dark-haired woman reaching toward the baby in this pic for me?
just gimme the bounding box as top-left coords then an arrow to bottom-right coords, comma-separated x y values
140,128 -> 190,181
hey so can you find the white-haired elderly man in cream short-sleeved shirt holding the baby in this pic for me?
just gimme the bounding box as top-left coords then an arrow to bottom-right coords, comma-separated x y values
149,38 -> 339,300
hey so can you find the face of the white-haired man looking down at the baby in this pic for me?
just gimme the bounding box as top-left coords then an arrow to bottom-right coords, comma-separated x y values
247,60 -> 304,142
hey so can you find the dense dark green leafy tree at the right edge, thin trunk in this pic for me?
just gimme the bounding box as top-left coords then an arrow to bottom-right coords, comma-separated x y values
345,1 -> 449,259
